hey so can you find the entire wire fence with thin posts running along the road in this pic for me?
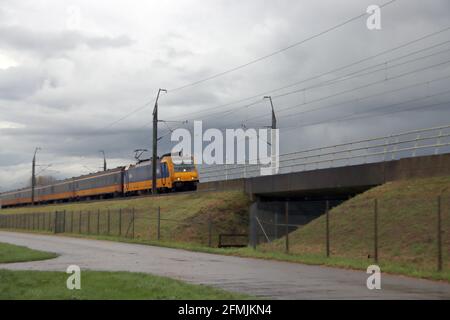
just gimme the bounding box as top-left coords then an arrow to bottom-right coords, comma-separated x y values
0,189 -> 450,271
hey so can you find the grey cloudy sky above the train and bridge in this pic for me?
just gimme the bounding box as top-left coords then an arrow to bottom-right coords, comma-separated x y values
0,0 -> 450,191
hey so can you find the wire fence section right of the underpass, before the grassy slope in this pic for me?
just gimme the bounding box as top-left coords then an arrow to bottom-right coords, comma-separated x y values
250,192 -> 450,270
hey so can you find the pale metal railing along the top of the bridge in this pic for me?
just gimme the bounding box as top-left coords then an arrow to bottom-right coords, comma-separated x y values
199,125 -> 450,182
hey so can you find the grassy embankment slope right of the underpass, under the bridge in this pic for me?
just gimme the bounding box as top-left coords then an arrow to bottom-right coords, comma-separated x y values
261,177 -> 450,281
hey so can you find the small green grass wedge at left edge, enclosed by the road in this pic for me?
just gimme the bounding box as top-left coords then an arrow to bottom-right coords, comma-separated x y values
0,243 -> 57,263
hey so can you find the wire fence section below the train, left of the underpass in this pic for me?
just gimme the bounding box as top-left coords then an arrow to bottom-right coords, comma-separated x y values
0,208 -> 248,247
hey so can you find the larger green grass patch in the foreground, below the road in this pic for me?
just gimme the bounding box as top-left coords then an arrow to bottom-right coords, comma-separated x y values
0,270 -> 250,300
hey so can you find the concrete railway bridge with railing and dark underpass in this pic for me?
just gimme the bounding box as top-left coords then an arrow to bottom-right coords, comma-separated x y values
199,125 -> 450,242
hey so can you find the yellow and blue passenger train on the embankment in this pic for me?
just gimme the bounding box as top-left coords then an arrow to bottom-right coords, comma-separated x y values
0,154 -> 199,208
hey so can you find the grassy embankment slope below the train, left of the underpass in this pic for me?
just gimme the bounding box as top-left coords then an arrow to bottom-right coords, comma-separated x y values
0,191 -> 249,245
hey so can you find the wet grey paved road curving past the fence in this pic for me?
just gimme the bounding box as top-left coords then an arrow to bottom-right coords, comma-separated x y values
0,232 -> 450,299
